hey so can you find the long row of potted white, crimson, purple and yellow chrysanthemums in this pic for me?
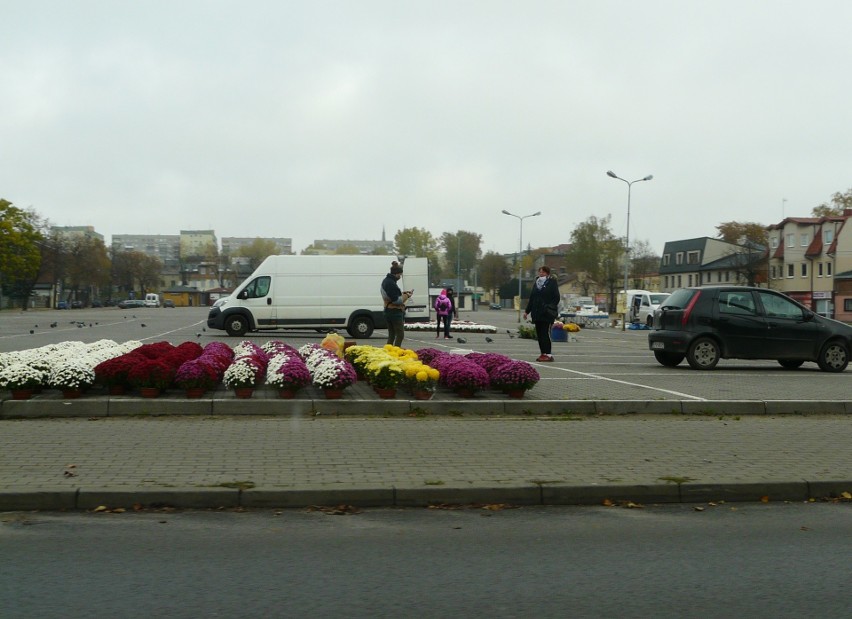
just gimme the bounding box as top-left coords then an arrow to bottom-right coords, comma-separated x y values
0,339 -> 539,399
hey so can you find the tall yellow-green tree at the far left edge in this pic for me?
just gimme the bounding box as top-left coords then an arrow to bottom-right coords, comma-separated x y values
0,199 -> 44,310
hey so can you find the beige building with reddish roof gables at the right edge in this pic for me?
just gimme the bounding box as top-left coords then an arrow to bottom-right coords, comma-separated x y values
767,209 -> 852,320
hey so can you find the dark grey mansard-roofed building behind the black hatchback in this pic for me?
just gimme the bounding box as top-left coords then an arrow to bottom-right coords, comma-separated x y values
659,236 -> 766,292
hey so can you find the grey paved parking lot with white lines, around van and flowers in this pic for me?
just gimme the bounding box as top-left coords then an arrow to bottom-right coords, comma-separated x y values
0,308 -> 852,402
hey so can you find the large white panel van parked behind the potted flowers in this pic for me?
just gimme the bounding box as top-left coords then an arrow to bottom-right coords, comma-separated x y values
207,255 -> 429,338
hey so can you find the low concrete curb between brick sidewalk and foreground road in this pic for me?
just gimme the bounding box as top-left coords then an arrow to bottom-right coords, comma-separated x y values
0,479 -> 852,512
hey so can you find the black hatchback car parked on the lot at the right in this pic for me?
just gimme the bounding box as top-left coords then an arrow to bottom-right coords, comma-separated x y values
648,286 -> 852,372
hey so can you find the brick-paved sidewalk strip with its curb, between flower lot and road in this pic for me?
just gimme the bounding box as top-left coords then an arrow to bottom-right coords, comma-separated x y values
0,401 -> 852,511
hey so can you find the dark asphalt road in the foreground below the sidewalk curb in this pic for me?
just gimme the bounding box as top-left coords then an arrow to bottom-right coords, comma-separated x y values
0,503 -> 852,619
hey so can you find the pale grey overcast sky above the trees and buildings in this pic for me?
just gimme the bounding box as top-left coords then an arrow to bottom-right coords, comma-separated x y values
0,0 -> 852,253
